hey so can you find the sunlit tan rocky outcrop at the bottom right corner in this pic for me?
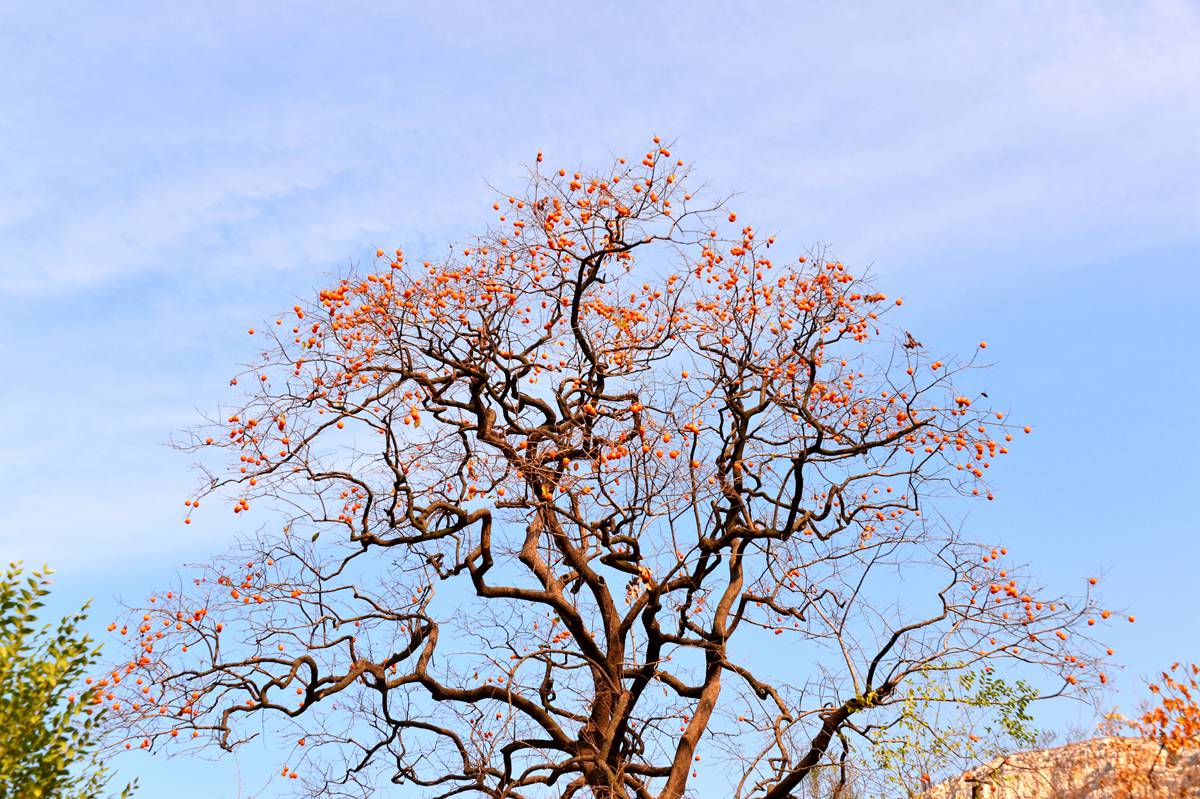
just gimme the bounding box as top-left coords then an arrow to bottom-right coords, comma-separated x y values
926,738 -> 1200,799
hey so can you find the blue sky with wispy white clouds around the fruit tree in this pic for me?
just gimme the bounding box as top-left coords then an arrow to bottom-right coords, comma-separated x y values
0,1 -> 1200,799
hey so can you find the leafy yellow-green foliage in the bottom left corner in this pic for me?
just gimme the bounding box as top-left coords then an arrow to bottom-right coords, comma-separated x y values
0,563 -> 133,799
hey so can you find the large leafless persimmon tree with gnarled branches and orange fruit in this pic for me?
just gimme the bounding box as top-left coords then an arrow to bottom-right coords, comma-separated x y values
106,139 -> 1118,799
